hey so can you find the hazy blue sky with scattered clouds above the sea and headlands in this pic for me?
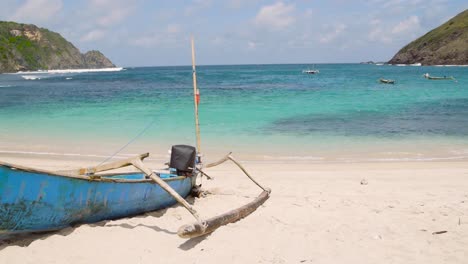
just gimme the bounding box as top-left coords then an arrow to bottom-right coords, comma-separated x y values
0,0 -> 468,66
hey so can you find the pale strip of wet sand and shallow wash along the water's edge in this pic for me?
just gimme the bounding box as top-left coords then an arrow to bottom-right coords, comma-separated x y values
0,136 -> 468,164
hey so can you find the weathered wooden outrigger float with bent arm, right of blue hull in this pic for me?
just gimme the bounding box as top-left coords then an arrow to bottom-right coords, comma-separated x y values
177,153 -> 271,238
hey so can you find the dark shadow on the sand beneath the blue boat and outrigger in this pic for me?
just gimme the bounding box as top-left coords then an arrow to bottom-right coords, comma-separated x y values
0,197 -> 209,251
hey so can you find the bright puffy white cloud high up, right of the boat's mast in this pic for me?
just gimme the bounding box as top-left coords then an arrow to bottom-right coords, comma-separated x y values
255,2 -> 295,30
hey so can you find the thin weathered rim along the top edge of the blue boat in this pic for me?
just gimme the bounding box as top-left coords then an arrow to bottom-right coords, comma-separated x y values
0,161 -> 189,183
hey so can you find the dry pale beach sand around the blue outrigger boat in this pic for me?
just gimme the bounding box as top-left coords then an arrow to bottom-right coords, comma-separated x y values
0,155 -> 468,264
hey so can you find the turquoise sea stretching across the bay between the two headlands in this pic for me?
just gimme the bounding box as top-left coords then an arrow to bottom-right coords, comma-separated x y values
0,64 -> 468,162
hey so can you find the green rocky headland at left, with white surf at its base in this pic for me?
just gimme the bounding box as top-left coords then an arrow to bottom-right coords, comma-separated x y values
0,21 -> 115,73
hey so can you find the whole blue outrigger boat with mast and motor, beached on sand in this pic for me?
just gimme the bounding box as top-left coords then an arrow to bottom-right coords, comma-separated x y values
0,39 -> 271,238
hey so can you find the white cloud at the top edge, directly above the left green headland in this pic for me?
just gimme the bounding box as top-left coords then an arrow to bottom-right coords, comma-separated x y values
10,0 -> 63,23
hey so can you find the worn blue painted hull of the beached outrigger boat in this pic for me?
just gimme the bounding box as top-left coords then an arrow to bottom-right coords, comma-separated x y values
0,164 -> 192,235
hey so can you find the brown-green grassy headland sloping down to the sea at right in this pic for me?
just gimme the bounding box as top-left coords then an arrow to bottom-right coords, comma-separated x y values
388,10 -> 468,65
